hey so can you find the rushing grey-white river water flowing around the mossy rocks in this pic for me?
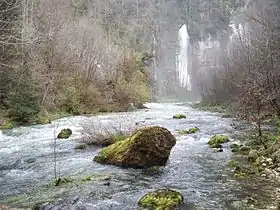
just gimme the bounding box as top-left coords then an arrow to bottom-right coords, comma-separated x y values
0,103 -> 258,210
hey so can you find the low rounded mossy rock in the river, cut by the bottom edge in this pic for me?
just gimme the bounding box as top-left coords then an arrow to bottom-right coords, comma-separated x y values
138,189 -> 184,210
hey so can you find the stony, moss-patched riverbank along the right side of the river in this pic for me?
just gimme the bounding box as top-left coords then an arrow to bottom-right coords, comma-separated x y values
191,103 -> 280,209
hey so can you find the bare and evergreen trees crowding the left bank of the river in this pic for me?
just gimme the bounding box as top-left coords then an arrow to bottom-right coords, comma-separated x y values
0,0 -> 155,126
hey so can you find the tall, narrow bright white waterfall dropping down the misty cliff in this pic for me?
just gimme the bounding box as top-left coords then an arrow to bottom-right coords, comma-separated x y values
176,24 -> 191,91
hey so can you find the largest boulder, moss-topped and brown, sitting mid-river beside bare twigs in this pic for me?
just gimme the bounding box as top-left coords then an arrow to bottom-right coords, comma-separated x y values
94,126 -> 176,168
